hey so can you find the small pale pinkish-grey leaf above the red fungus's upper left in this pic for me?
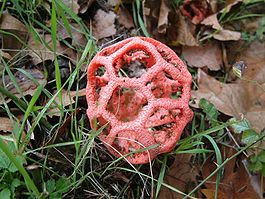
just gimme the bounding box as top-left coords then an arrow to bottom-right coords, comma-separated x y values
92,9 -> 116,39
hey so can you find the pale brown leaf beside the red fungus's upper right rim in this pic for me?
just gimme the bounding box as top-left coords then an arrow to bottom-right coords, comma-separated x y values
182,42 -> 223,71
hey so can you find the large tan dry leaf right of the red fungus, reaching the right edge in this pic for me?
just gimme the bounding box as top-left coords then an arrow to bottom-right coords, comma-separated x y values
191,41 -> 265,131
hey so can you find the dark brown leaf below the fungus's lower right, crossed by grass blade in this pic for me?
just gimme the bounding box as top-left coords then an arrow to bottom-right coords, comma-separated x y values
158,154 -> 199,199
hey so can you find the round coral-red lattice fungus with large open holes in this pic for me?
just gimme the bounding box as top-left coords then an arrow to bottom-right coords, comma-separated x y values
86,37 -> 193,164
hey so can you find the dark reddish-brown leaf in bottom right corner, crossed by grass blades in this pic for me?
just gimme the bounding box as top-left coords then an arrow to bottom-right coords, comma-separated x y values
202,146 -> 262,199
